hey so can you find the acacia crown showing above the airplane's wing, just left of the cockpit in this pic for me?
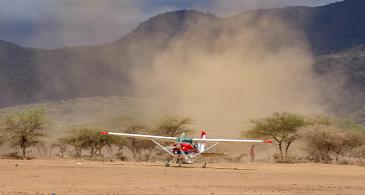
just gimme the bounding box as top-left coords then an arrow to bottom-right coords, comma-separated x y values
154,115 -> 193,137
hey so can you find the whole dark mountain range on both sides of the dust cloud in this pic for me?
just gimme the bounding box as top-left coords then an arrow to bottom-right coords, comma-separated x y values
0,0 -> 365,121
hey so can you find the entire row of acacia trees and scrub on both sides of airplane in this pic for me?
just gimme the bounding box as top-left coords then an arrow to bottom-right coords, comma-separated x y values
0,107 -> 365,164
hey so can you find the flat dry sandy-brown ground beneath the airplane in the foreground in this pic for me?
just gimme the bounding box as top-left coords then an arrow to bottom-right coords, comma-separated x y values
0,160 -> 365,195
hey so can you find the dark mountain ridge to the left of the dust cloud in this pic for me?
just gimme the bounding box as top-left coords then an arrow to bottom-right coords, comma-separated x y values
0,11 -> 216,107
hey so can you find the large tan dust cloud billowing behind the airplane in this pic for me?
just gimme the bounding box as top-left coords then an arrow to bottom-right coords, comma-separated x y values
133,16 -> 322,136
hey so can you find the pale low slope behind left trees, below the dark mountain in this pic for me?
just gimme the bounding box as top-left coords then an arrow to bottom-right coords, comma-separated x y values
0,96 -> 148,134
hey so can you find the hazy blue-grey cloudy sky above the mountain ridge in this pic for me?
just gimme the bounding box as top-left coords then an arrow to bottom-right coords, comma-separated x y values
0,0 -> 340,48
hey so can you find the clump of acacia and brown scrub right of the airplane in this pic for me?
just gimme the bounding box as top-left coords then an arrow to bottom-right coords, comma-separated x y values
244,113 -> 365,164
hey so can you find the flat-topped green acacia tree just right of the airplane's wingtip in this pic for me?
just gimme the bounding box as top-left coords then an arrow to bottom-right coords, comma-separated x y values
244,112 -> 309,160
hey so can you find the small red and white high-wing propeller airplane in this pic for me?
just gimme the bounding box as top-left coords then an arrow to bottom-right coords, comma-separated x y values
101,130 -> 272,168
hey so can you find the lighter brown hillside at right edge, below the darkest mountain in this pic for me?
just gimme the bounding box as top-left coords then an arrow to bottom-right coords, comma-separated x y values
314,45 -> 365,119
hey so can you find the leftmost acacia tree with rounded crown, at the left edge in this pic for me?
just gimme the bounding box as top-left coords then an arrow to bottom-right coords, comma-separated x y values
3,108 -> 49,159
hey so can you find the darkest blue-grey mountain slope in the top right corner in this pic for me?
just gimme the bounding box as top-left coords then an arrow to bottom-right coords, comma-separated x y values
233,0 -> 365,55
